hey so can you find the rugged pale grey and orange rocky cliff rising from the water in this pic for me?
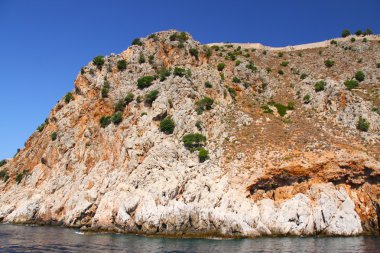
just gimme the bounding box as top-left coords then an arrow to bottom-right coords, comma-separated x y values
0,31 -> 380,237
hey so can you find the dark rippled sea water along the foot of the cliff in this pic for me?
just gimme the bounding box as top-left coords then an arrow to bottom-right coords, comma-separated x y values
0,224 -> 380,253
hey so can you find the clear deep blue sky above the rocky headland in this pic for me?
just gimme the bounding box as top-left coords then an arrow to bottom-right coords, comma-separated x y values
0,0 -> 380,159
